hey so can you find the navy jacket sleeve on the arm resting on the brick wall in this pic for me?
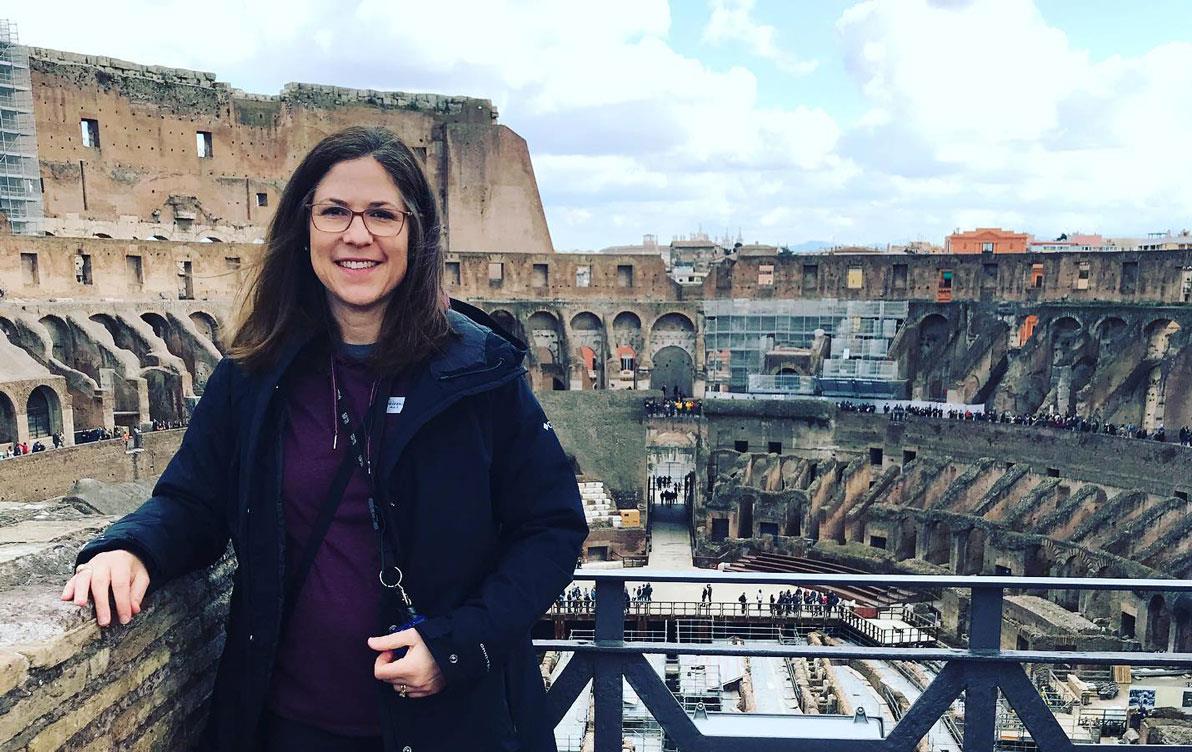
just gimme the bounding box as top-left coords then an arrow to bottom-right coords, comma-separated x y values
76,359 -> 236,588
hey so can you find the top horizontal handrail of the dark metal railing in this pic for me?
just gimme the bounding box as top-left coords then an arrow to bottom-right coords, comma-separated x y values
572,567 -> 1192,592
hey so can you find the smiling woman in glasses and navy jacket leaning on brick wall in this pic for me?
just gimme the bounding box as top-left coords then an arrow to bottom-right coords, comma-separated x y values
62,128 -> 586,752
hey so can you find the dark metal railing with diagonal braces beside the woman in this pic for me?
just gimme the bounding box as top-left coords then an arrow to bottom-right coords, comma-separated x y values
535,570 -> 1192,752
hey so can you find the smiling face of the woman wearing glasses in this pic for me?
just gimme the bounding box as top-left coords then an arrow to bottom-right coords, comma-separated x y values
309,156 -> 410,336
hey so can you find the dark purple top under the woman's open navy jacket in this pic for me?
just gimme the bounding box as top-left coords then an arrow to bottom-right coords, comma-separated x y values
269,346 -> 404,737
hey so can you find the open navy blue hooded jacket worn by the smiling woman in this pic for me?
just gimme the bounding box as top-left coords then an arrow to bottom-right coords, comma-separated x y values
79,302 -> 588,752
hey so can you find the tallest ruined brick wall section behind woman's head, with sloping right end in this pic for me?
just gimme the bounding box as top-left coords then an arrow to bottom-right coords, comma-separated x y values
30,48 -> 552,253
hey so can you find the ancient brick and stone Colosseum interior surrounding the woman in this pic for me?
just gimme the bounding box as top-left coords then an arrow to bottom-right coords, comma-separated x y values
0,33 -> 1192,752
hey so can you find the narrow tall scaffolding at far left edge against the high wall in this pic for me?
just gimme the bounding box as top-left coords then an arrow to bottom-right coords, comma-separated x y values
0,18 -> 44,235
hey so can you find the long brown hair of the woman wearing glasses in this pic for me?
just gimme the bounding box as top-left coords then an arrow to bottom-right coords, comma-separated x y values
229,128 -> 451,372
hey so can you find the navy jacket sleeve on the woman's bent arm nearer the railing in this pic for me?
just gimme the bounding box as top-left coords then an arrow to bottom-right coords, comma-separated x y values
417,378 -> 588,685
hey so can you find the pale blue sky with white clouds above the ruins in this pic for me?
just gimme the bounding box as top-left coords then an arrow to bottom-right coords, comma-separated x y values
9,0 -> 1192,250
